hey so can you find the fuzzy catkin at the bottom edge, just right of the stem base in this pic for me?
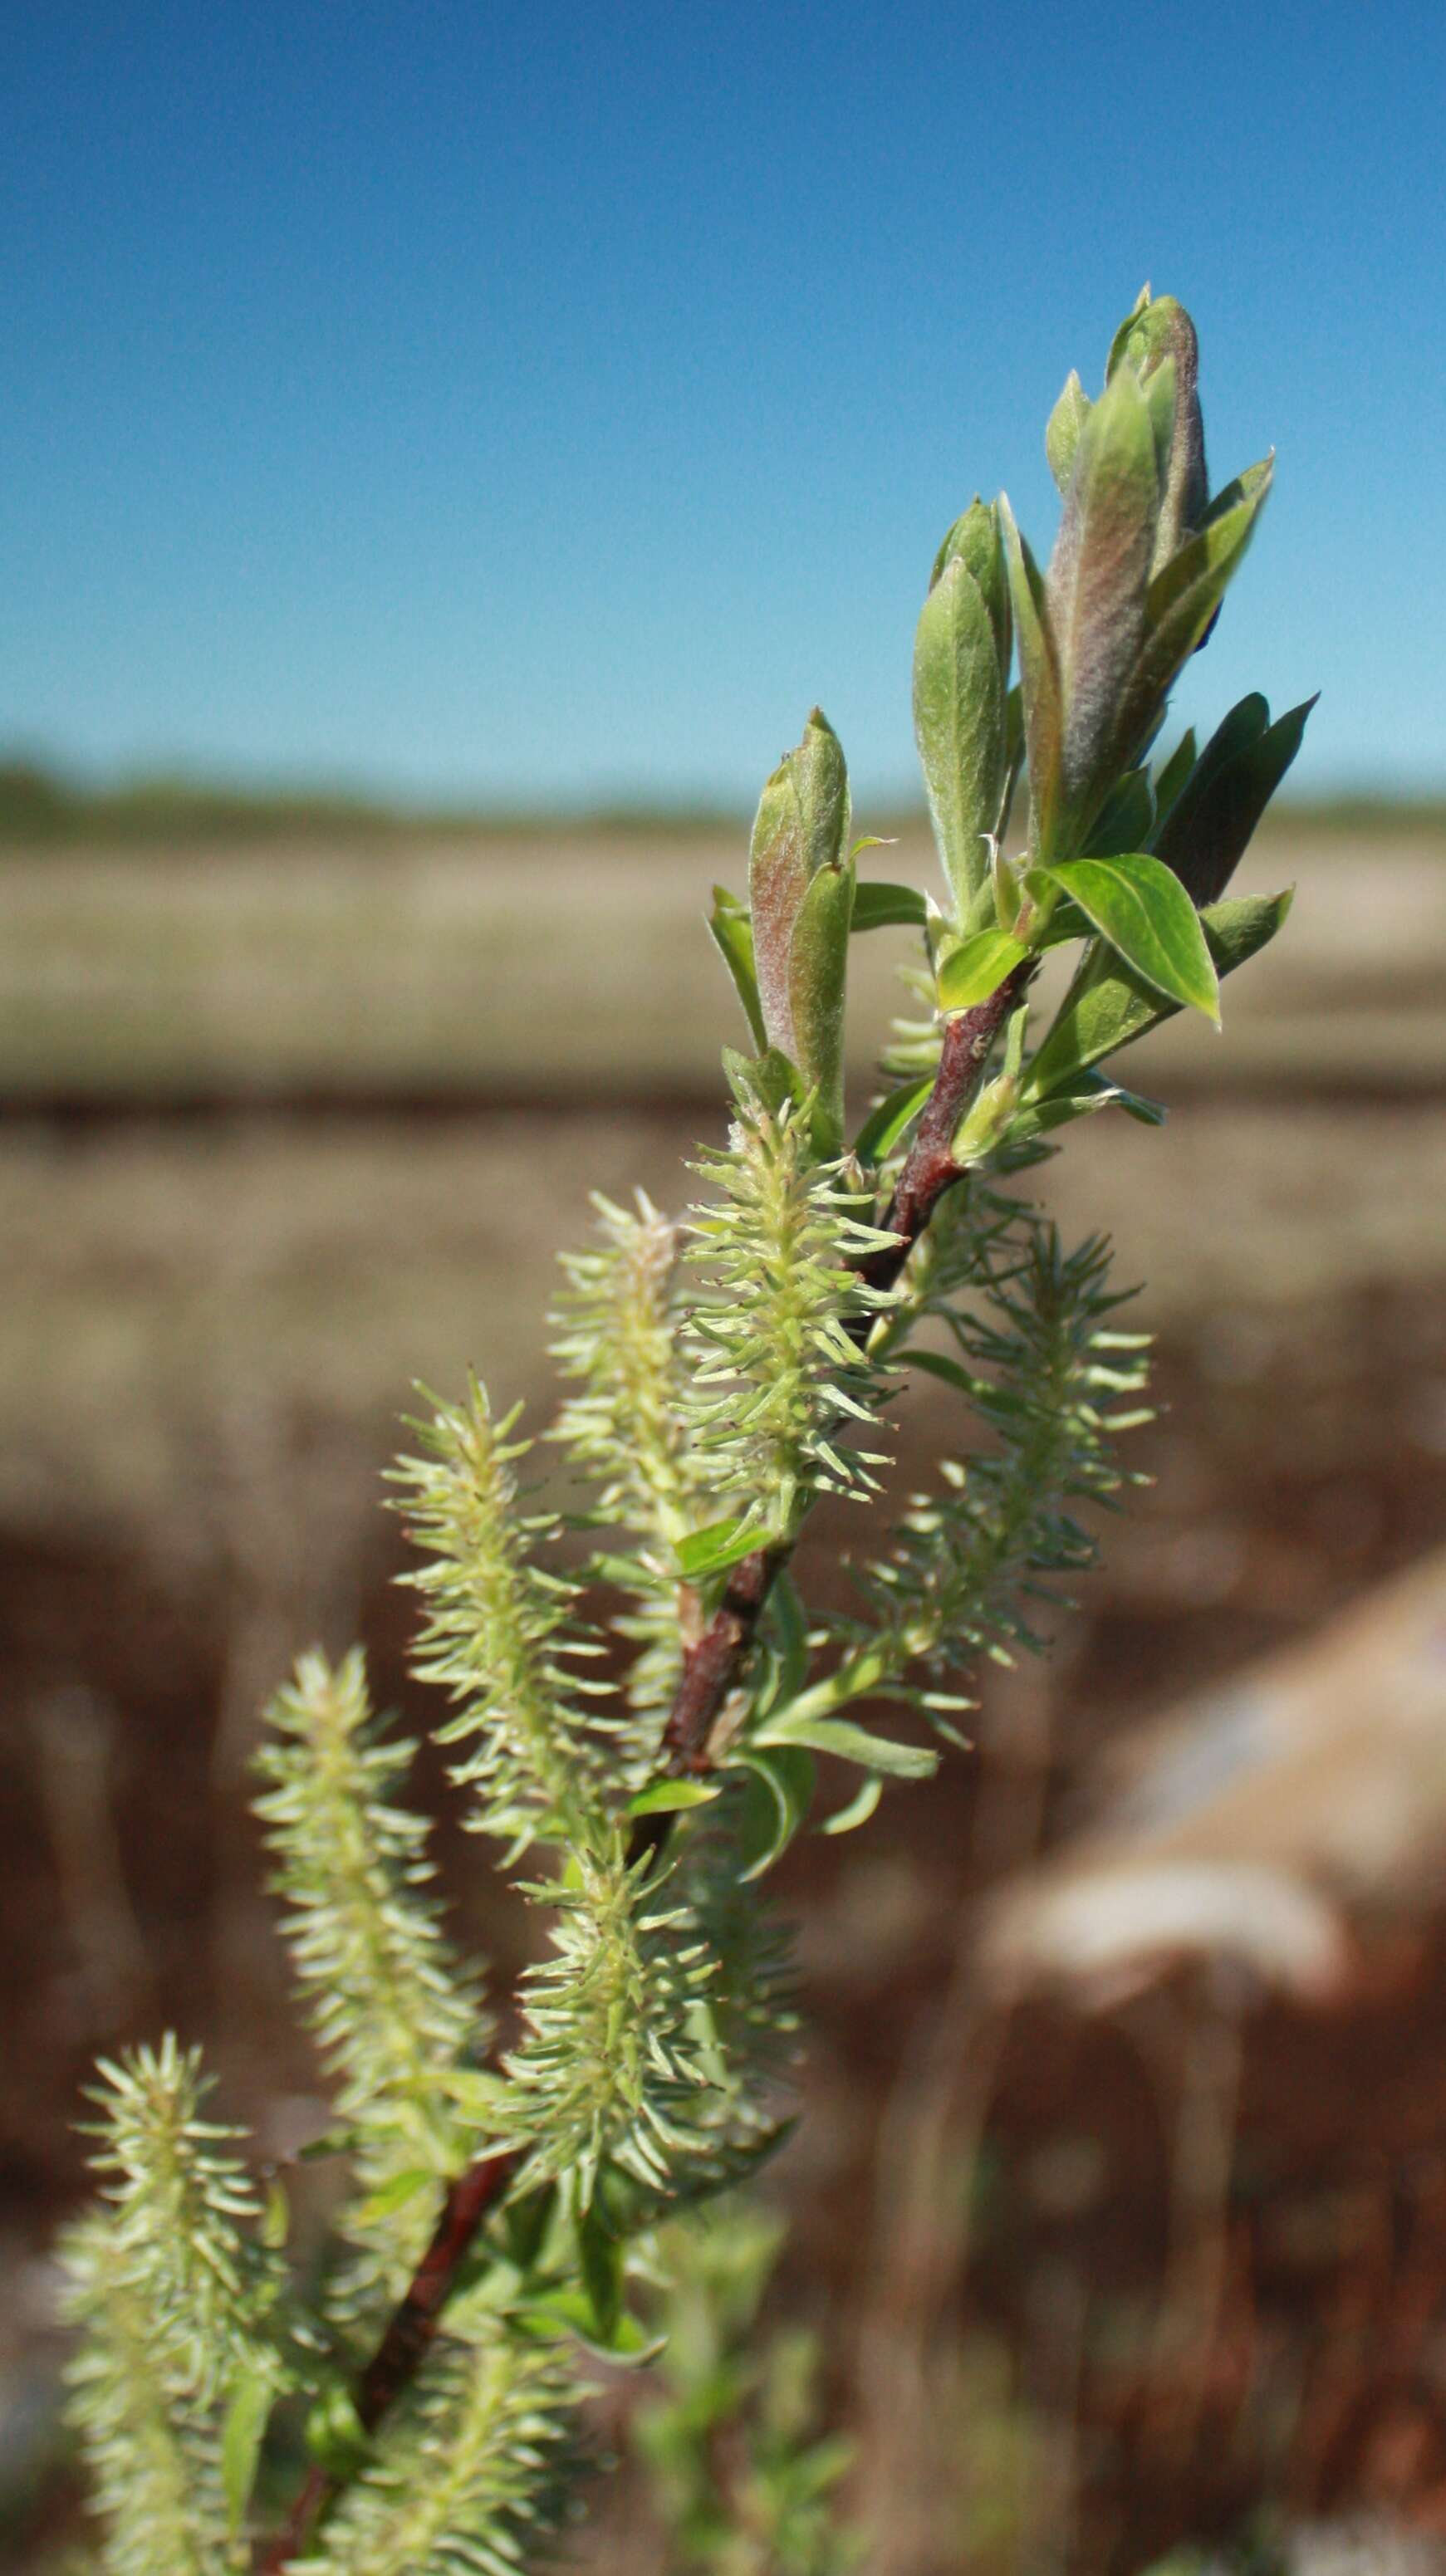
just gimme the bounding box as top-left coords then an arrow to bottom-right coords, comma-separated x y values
306,2329 -> 575,2576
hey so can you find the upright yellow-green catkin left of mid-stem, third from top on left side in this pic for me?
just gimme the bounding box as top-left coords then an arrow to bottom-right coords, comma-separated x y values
392,1379 -> 603,1858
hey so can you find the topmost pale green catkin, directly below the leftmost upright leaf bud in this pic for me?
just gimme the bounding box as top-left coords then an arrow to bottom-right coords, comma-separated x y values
686,1103 -> 895,1538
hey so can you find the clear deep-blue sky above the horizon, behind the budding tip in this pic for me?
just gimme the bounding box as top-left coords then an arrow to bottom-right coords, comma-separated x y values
0,0 -> 1446,801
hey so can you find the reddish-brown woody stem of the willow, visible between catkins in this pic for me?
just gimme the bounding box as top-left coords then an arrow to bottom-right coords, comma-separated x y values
257,961 -> 1033,2576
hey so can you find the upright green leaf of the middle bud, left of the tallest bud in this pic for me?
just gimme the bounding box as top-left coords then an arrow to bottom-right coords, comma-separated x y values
913,536 -> 1007,919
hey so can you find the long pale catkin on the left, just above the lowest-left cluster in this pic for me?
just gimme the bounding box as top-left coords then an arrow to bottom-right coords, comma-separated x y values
255,1648 -> 488,2267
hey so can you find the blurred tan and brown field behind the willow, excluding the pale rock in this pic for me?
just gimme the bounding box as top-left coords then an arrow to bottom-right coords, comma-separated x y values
0,827 -> 1446,2576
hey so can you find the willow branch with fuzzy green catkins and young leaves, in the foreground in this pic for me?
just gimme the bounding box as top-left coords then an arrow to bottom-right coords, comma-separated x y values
65,291 -> 1306,2576
